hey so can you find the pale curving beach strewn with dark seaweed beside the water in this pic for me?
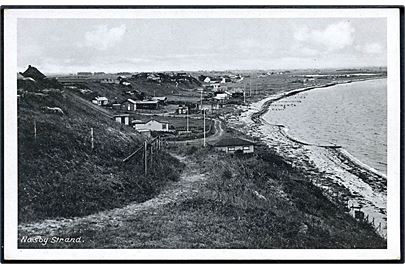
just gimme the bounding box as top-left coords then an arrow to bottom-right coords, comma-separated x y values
226,78 -> 387,237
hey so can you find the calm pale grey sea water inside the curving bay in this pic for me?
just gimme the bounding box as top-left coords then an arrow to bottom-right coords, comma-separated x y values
264,79 -> 387,174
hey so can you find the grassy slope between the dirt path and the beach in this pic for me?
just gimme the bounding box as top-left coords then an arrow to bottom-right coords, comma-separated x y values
131,146 -> 386,248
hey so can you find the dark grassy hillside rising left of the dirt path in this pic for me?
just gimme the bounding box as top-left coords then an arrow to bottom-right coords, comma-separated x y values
18,87 -> 181,222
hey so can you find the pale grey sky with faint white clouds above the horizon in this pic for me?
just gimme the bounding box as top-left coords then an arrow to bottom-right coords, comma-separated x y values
17,18 -> 387,73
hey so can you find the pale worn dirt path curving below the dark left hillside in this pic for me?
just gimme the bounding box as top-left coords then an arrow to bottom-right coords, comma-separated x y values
18,154 -> 206,237
